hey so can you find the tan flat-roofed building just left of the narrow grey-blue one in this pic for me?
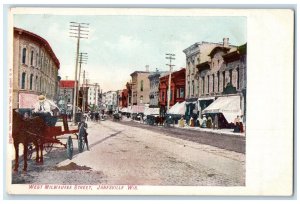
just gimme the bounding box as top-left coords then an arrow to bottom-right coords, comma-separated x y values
130,71 -> 151,105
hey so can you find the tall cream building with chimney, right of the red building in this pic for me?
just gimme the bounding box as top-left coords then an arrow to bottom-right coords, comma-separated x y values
183,38 -> 236,100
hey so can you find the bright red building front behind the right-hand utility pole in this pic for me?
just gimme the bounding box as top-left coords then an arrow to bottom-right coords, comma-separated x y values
159,68 -> 186,113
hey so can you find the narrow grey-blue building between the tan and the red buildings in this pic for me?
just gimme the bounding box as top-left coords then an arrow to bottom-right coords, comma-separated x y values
148,69 -> 167,108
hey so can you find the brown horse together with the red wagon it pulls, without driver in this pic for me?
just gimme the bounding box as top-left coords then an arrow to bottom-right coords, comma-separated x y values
12,106 -> 87,171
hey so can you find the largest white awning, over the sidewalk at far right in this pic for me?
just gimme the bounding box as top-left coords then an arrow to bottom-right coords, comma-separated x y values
202,96 -> 241,123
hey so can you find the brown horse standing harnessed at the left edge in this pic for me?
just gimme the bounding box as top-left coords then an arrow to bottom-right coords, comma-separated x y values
12,109 -> 47,171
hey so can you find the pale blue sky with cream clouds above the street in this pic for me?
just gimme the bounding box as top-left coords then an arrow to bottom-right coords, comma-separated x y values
13,14 -> 247,92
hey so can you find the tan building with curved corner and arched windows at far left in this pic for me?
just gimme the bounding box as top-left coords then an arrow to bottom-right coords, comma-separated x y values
12,27 -> 60,108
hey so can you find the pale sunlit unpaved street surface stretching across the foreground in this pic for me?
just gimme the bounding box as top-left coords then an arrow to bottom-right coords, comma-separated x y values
13,120 -> 245,186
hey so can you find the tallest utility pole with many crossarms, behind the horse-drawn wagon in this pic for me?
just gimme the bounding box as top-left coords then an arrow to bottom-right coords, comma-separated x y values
70,22 -> 89,124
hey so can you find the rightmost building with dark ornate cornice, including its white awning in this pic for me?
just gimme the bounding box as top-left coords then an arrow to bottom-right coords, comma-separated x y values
197,44 -> 247,123
